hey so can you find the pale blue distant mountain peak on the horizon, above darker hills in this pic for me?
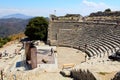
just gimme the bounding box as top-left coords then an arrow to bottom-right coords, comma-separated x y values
2,13 -> 33,19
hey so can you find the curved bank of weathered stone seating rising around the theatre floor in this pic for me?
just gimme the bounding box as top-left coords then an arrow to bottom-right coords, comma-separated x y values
52,22 -> 120,57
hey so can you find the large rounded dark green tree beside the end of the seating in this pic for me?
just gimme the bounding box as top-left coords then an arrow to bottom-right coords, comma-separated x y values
25,17 -> 48,41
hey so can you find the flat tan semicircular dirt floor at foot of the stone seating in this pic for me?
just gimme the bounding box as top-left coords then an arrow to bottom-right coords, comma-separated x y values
57,47 -> 85,69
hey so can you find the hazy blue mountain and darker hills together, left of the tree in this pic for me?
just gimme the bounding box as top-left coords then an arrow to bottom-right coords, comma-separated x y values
0,14 -> 49,37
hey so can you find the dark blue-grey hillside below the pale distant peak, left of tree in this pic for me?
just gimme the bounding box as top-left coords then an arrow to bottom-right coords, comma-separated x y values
0,18 -> 29,37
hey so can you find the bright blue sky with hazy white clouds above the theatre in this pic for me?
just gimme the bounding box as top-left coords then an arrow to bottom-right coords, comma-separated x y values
0,0 -> 120,17
